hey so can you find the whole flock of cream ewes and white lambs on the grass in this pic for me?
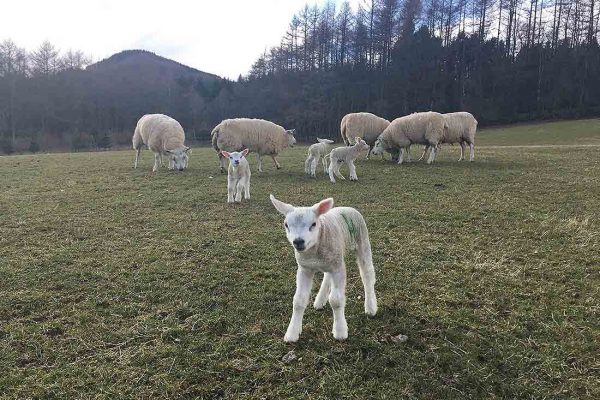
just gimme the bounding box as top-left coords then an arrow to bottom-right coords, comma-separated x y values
133,112 -> 477,342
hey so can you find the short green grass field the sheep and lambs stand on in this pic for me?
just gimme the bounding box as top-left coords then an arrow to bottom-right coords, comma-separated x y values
0,120 -> 600,399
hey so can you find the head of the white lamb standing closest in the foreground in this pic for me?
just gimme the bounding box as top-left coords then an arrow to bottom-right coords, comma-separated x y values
270,195 -> 333,252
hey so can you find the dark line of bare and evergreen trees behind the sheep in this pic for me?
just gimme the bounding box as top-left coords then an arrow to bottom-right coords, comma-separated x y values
0,0 -> 600,152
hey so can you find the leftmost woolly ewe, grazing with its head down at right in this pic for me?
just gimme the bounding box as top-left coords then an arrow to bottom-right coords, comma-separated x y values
132,114 -> 191,172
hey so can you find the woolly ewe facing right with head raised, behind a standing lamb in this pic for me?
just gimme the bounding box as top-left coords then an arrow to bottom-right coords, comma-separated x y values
211,118 -> 296,172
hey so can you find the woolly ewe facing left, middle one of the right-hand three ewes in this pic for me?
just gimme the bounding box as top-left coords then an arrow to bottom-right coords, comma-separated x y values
372,111 -> 446,164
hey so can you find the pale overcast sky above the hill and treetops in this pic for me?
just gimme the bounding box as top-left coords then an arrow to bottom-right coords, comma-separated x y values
0,0 -> 360,79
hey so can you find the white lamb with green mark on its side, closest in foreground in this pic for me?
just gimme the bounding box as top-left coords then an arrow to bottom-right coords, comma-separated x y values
271,195 -> 377,342
